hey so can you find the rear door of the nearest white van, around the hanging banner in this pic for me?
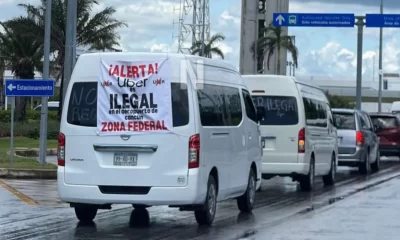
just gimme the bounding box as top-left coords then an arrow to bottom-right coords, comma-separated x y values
61,79 -> 195,187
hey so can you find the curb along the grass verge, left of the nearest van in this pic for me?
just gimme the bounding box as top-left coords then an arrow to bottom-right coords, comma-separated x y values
0,168 -> 57,180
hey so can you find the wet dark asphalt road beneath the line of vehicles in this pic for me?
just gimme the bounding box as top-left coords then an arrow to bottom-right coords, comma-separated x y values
0,162 -> 400,240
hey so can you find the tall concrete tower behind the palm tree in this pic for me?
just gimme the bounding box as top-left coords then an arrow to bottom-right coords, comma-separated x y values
239,0 -> 289,75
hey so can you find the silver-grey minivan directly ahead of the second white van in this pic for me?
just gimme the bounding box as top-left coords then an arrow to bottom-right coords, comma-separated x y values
332,108 -> 380,174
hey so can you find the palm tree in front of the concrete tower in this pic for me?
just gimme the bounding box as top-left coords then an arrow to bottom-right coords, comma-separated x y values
251,23 -> 299,75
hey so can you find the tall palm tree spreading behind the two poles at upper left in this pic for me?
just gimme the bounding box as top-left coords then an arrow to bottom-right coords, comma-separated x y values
14,0 -> 128,116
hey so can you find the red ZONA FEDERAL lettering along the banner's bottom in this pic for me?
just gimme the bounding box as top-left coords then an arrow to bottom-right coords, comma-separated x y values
101,120 -> 168,132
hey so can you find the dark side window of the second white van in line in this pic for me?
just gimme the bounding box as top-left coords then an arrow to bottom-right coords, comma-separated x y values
303,97 -> 328,127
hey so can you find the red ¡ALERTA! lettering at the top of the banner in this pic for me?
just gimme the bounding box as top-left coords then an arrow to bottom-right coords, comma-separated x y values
108,63 -> 158,78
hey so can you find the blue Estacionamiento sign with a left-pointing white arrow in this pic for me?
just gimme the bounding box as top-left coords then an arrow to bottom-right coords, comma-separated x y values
5,79 -> 55,97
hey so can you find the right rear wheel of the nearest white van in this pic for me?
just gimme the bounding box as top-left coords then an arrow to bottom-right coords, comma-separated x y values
194,175 -> 217,225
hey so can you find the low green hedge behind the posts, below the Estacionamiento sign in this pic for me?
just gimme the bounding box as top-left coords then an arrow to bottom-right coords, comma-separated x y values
0,120 -> 60,139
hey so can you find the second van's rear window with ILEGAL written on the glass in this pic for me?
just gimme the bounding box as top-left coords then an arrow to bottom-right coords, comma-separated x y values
252,96 -> 299,125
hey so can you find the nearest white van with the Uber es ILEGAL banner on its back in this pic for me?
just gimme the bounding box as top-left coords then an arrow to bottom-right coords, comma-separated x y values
58,53 -> 262,225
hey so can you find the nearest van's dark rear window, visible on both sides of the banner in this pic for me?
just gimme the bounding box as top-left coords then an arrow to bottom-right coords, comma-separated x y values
67,82 -> 189,127
